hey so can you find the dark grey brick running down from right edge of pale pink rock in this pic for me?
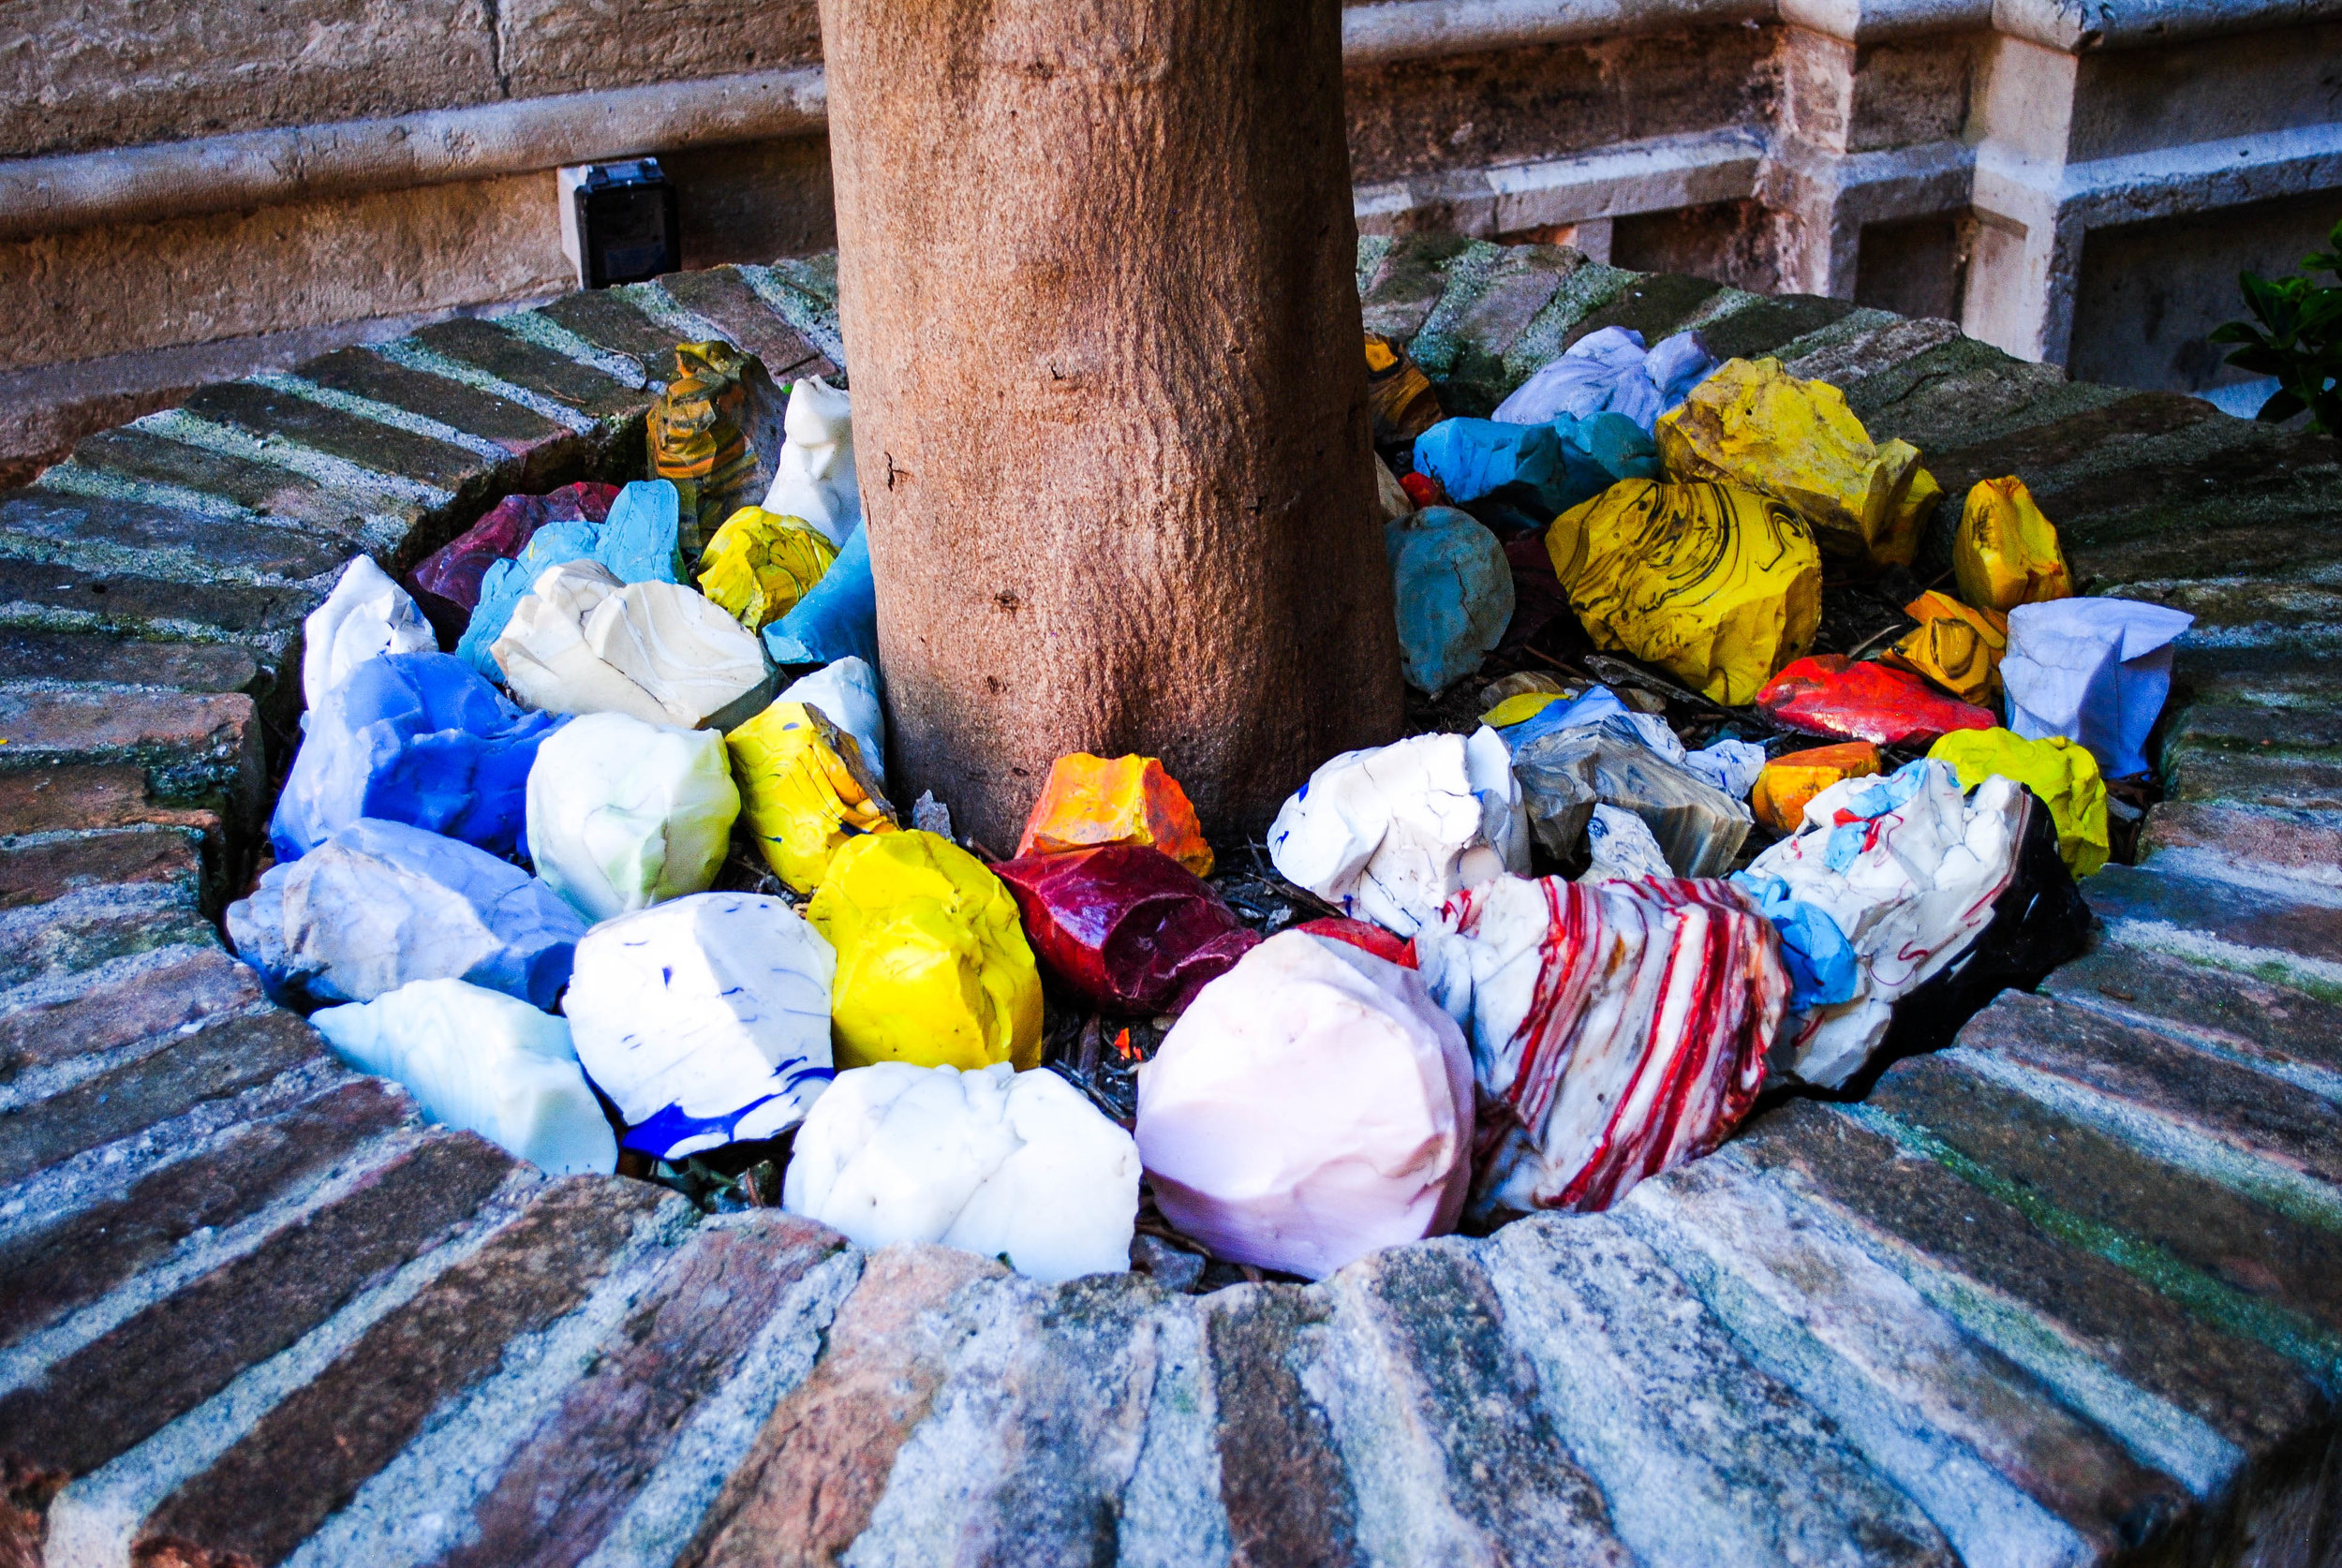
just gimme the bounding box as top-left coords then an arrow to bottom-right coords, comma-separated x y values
1328,1245 -> 1635,1568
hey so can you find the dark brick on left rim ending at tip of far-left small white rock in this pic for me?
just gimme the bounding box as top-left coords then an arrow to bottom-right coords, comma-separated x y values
0,489 -> 349,583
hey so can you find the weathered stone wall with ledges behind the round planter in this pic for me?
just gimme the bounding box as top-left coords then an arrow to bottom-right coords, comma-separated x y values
0,0 -> 2342,478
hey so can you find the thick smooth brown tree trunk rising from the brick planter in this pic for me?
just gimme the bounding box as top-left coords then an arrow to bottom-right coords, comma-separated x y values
823,0 -> 1403,851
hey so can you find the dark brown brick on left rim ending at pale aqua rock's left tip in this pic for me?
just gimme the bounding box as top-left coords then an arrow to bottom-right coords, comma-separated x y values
0,1013 -> 326,1187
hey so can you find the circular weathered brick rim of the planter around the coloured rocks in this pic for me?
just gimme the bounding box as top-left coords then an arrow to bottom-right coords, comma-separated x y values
0,236 -> 2342,1568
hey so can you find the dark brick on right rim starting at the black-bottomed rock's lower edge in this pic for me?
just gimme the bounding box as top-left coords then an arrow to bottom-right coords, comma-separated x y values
1958,992 -> 2342,1184
